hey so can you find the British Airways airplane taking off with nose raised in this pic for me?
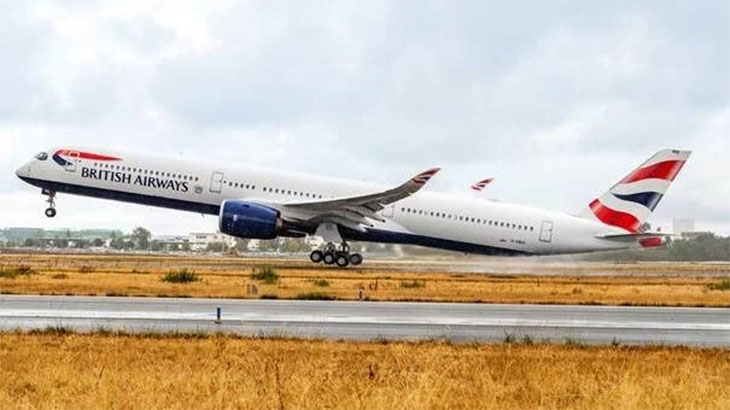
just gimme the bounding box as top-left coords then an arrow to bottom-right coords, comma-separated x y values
16,148 -> 691,267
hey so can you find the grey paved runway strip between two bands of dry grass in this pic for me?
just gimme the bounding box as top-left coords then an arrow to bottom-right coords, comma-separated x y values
0,295 -> 730,347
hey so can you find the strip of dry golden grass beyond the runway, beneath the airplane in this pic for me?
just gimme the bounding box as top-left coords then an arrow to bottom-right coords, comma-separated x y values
0,254 -> 730,306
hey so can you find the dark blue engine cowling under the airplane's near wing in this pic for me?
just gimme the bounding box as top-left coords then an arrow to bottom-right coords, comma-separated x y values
218,199 -> 281,239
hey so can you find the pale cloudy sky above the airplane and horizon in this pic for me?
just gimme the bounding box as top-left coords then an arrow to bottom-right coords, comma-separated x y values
0,0 -> 730,234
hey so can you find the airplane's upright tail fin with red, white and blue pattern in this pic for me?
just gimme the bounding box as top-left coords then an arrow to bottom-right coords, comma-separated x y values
581,149 -> 692,232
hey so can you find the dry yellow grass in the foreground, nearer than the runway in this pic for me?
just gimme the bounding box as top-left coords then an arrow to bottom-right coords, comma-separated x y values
0,334 -> 730,409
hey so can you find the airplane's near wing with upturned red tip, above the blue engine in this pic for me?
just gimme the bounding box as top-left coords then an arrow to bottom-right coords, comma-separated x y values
278,168 -> 440,231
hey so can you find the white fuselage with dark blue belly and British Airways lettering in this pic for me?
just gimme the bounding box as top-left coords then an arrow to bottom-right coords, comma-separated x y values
17,150 -> 630,254
